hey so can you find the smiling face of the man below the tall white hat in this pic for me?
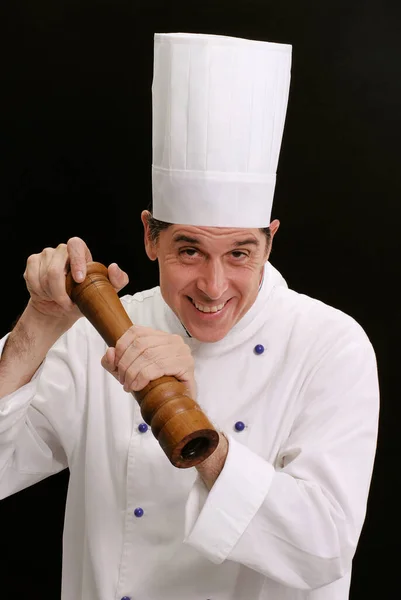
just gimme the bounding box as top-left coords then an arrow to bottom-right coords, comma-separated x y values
142,213 -> 278,342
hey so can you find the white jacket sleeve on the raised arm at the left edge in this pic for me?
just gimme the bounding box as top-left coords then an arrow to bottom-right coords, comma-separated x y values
0,322 -> 87,499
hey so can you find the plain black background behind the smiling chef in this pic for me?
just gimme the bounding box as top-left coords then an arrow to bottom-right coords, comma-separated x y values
0,0 -> 401,600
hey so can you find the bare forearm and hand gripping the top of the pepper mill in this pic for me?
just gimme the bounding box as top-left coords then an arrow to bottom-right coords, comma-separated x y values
0,237 -> 128,399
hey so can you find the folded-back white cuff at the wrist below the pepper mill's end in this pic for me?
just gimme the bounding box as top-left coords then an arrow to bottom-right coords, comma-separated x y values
184,436 -> 274,564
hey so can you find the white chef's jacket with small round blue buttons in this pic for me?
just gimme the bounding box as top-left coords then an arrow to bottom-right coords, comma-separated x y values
0,263 -> 379,600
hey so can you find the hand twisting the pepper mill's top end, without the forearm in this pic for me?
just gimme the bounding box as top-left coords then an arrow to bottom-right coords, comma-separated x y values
24,237 -> 128,325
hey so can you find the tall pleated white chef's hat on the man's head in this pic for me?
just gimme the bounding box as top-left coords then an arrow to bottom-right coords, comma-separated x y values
152,33 -> 292,227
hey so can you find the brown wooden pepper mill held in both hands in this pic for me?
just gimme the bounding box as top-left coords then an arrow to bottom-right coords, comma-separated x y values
66,262 -> 219,468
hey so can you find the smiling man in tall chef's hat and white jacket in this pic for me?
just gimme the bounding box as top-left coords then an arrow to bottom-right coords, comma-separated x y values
0,33 -> 379,600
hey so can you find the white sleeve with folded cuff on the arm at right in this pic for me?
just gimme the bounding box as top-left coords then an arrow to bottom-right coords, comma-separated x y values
185,326 -> 379,590
